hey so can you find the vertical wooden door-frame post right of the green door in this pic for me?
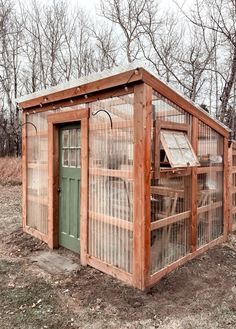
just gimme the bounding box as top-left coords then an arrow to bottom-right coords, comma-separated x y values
80,117 -> 89,266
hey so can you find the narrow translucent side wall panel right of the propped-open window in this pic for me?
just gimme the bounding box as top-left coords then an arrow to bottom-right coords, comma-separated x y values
197,122 -> 223,247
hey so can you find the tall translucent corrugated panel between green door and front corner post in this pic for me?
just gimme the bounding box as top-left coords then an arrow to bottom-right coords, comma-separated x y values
89,95 -> 133,273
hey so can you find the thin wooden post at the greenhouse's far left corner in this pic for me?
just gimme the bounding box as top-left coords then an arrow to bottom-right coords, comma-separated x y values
22,112 -> 28,230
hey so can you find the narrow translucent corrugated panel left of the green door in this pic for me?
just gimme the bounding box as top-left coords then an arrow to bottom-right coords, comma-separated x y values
26,113 -> 48,234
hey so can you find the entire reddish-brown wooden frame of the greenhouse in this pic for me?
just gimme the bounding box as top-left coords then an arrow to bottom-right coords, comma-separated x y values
19,68 -> 230,290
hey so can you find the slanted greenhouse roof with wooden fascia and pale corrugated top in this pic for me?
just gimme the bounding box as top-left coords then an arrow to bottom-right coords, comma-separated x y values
15,63 -> 230,136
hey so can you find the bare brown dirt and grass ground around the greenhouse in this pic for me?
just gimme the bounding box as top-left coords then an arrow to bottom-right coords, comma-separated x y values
0,186 -> 236,329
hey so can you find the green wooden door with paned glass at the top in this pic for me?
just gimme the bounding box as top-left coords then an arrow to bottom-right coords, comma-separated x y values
59,124 -> 81,252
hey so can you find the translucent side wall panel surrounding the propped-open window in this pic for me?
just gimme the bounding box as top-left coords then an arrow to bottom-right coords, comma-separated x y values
151,92 -> 192,274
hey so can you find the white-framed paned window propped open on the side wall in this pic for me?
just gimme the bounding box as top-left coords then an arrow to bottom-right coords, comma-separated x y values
161,130 -> 200,168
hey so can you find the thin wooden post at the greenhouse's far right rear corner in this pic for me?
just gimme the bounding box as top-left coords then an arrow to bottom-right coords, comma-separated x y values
223,137 -> 229,241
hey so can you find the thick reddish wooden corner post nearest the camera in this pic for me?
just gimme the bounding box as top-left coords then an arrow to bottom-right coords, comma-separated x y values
133,84 -> 152,290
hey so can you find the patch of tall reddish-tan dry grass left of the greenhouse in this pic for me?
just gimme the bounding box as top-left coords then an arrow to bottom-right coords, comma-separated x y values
0,157 -> 21,185
